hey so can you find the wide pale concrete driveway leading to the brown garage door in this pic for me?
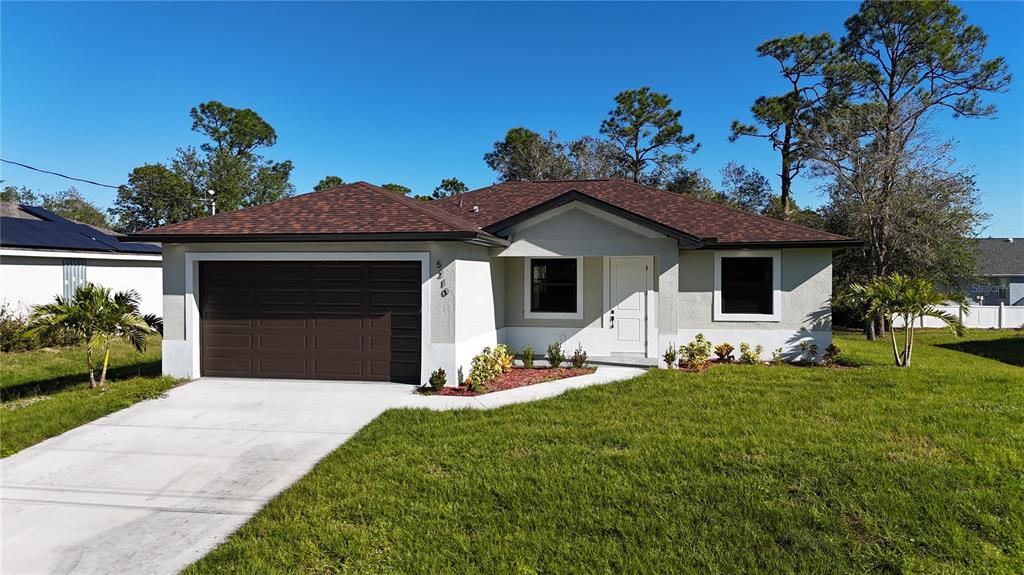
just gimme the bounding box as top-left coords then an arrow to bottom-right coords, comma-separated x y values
0,379 -> 412,575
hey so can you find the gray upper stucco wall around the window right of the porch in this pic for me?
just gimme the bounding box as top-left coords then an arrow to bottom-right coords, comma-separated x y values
678,249 -> 831,331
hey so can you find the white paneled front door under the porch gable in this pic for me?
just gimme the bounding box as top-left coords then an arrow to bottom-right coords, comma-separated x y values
608,257 -> 647,353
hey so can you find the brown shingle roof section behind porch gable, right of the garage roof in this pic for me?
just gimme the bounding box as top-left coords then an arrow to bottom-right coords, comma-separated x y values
437,179 -> 853,245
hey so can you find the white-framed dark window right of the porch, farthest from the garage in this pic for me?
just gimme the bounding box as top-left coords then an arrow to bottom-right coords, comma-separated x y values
715,252 -> 780,321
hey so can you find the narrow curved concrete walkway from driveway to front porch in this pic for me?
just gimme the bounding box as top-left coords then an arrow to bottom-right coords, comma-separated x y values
398,365 -> 646,411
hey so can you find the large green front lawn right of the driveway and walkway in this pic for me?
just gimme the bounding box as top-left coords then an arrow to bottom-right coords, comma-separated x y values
185,331 -> 1024,575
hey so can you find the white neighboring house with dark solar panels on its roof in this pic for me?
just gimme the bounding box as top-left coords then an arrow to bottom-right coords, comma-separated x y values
0,202 -> 163,315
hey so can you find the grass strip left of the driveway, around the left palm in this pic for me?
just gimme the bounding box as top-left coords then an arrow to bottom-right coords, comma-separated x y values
0,338 -> 175,457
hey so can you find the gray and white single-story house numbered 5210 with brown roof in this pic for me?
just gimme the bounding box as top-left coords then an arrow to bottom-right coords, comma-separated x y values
132,180 -> 857,383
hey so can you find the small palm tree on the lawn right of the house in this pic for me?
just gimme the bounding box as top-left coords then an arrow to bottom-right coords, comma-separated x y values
846,273 -> 970,367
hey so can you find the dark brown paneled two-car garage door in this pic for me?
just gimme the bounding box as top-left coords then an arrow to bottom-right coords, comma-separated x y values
199,262 -> 421,384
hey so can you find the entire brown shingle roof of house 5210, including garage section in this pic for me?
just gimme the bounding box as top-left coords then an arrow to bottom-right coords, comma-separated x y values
132,175 -> 854,246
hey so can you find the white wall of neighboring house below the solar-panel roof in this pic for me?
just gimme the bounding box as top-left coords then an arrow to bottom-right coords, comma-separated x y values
0,250 -> 162,315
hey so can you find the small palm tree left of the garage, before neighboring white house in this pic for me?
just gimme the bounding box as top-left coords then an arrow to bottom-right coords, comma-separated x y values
28,283 -> 163,388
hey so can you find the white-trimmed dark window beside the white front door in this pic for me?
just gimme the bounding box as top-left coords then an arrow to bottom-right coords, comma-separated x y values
525,258 -> 583,318
